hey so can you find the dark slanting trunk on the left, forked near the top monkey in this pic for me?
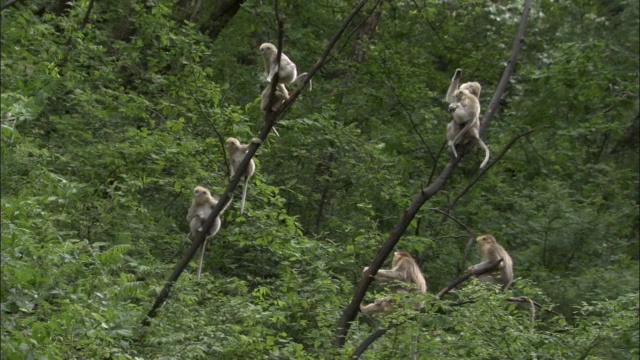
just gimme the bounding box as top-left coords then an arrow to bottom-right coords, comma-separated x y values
142,0 -> 368,326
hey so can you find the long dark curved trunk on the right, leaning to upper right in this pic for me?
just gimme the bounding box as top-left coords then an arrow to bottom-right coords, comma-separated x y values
338,0 -> 531,347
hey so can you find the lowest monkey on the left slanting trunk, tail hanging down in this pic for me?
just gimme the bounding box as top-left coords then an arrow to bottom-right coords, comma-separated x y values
187,186 -> 231,280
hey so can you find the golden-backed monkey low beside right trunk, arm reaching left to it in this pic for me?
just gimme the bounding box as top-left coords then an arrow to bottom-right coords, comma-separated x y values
360,251 -> 427,313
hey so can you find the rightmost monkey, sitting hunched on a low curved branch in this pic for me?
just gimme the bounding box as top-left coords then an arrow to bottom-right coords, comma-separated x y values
467,234 -> 513,291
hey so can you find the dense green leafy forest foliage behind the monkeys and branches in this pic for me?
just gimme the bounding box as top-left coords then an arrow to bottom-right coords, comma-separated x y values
0,0 -> 640,359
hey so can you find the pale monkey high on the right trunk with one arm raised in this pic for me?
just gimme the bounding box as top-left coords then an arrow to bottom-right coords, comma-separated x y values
446,69 -> 489,168
